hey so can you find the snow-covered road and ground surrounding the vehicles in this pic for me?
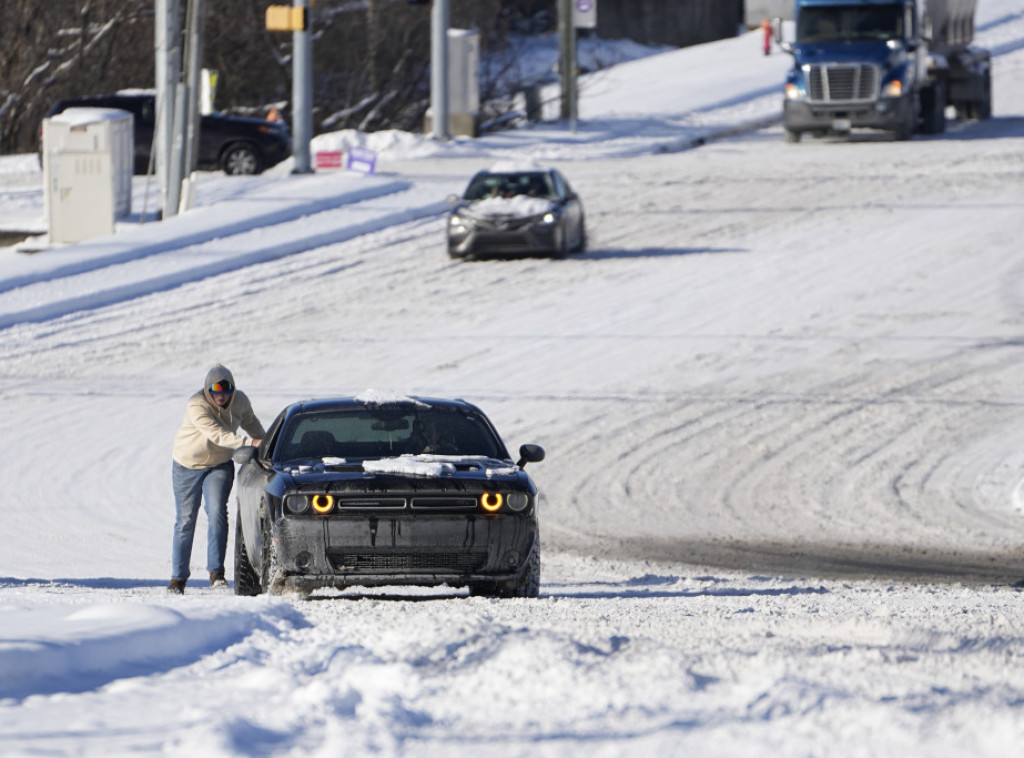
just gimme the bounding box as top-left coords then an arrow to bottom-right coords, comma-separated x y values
0,7 -> 1024,758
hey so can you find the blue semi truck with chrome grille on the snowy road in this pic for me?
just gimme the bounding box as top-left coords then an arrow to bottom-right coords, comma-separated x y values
776,0 -> 992,142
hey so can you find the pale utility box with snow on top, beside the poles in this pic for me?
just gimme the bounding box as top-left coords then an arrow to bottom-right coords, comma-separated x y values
43,108 -> 135,243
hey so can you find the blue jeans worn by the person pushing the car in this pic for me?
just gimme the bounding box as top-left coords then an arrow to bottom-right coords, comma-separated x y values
171,461 -> 234,581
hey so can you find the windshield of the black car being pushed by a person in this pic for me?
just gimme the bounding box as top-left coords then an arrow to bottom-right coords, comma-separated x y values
273,406 -> 508,463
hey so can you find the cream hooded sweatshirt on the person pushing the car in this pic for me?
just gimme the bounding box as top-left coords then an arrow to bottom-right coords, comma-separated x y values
173,364 -> 266,468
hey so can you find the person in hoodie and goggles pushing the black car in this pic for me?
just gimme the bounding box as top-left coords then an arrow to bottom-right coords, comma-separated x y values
167,364 -> 266,595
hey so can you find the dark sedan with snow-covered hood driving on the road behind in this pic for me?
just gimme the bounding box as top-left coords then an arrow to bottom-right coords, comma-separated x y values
447,165 -> 587,258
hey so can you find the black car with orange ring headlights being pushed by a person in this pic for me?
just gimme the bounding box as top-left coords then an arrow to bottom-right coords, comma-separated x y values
234,392 -> 544,597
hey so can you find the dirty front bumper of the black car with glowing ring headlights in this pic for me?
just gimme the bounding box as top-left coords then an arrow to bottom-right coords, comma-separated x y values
273,514 -> 538,592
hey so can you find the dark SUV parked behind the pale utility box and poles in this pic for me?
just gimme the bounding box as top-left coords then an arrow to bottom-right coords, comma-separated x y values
46,90 -> 292,174
